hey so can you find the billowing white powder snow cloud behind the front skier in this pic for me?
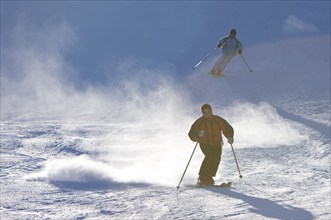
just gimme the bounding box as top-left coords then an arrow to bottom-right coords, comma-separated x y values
1,19 -> 329,185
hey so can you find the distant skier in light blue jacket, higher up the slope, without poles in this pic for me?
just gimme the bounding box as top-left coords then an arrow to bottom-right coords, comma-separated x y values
210,29 -> 243,77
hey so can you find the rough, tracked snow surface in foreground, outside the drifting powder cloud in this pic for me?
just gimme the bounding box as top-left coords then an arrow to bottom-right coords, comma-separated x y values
0,99 -> 331,219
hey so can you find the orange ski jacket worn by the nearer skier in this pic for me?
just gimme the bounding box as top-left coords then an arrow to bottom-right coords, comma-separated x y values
188,115 -> 234,145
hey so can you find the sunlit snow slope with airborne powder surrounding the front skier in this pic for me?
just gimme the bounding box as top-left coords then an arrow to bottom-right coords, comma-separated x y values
0,31 -> 331,219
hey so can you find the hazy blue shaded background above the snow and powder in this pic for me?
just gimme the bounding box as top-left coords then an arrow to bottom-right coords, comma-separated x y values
1,1 -> 330,82
